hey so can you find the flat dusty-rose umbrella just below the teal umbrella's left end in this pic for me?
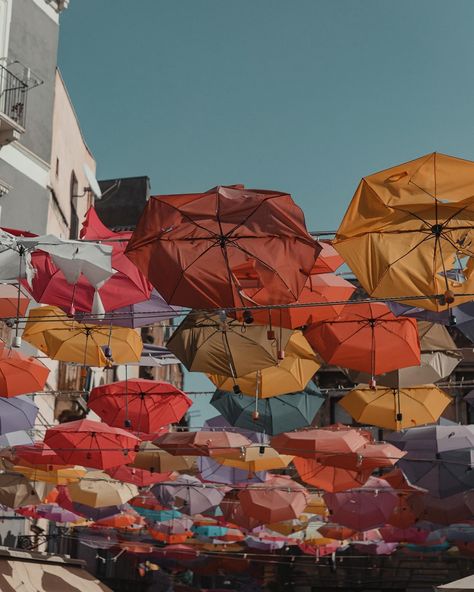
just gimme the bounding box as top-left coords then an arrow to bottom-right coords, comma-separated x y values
153,430 -> 251,456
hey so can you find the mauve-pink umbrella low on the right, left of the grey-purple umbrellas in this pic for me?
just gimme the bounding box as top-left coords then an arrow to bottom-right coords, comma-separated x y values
324,477 -> 397,531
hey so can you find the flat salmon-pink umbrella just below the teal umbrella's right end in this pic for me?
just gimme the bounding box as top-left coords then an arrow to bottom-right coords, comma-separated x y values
270,428 -> 368,459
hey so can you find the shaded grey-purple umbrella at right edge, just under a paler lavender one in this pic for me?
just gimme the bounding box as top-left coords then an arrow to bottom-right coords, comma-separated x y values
398,449 -> 474,498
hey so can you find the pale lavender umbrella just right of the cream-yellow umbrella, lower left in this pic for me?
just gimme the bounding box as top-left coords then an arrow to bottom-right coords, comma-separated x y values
152,475 -> 225,515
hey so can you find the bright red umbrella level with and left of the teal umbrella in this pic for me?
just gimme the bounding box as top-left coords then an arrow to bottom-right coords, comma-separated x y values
87,378 -> 192,434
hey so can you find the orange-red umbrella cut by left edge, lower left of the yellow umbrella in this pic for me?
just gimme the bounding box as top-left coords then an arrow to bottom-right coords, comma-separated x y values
0,347 -> 49,397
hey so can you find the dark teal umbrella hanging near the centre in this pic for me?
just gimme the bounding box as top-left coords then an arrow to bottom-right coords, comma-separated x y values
211,382 -> 325,436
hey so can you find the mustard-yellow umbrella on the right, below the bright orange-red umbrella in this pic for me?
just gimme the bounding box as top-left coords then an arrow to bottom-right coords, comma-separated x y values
339,384 -> 452,430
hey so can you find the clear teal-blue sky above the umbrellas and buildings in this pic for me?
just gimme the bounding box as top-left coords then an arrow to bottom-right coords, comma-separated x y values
59,0 -> 474,426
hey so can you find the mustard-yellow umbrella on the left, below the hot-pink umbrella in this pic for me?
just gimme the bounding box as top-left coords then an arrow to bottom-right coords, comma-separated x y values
23,306 -> 143,366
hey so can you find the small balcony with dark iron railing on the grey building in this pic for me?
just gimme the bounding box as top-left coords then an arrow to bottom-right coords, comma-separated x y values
0,65 -> 28,147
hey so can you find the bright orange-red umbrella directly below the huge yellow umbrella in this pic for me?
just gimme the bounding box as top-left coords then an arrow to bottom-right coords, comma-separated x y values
305,303 -> 420,379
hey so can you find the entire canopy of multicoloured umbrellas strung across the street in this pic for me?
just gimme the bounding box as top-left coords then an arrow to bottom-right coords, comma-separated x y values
0,153 -> 474,565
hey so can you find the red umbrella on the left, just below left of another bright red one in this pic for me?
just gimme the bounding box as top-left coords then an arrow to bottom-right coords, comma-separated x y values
44,419 -> 140,469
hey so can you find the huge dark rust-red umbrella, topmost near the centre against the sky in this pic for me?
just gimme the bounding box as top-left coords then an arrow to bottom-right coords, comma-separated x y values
126,187 -> 320,308
